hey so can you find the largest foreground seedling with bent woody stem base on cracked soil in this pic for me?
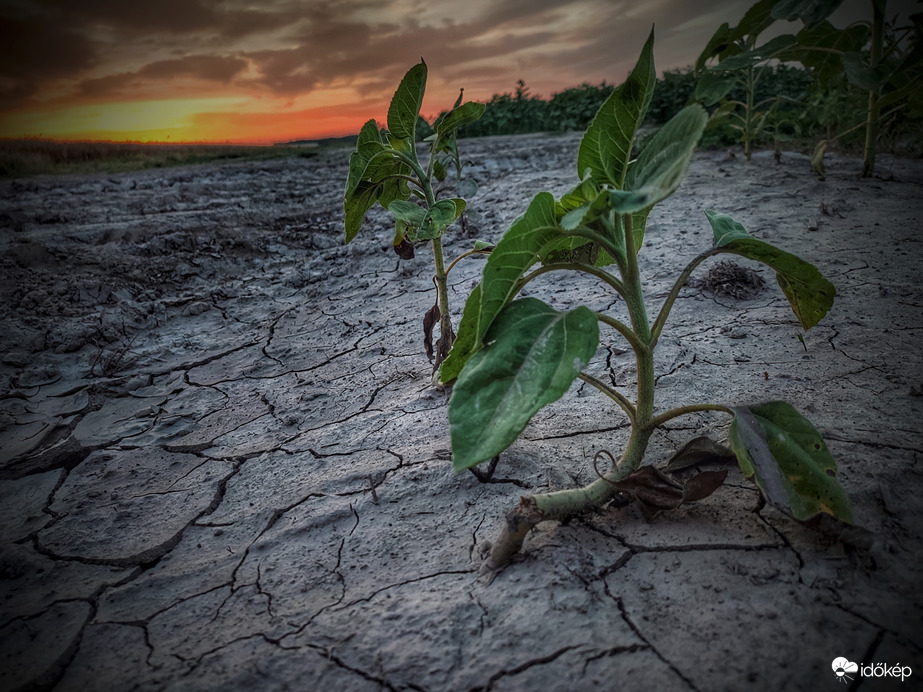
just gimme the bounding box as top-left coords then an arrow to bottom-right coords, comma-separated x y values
441,32 -> 852,569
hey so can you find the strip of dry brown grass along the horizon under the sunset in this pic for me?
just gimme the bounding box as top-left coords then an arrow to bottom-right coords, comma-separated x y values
0,139 -> 317,178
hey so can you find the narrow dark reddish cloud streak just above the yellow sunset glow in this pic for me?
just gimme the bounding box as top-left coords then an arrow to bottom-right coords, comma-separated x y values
78,55 -> 247,98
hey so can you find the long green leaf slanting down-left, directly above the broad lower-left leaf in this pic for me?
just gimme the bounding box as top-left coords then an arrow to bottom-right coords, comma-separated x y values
477,192 -> 562,342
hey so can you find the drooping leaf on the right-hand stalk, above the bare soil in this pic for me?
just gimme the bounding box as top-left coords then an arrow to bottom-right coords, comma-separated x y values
705,209 -> 836,329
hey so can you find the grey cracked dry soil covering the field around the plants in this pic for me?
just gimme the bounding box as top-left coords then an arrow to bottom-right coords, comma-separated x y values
0,135 -> 923,692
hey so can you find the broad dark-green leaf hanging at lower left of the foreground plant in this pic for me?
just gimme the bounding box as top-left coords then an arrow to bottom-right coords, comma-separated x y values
449,298 -> 599,471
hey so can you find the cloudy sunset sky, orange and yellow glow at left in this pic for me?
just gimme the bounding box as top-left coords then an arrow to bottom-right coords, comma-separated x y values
0,0 -> 919,143
